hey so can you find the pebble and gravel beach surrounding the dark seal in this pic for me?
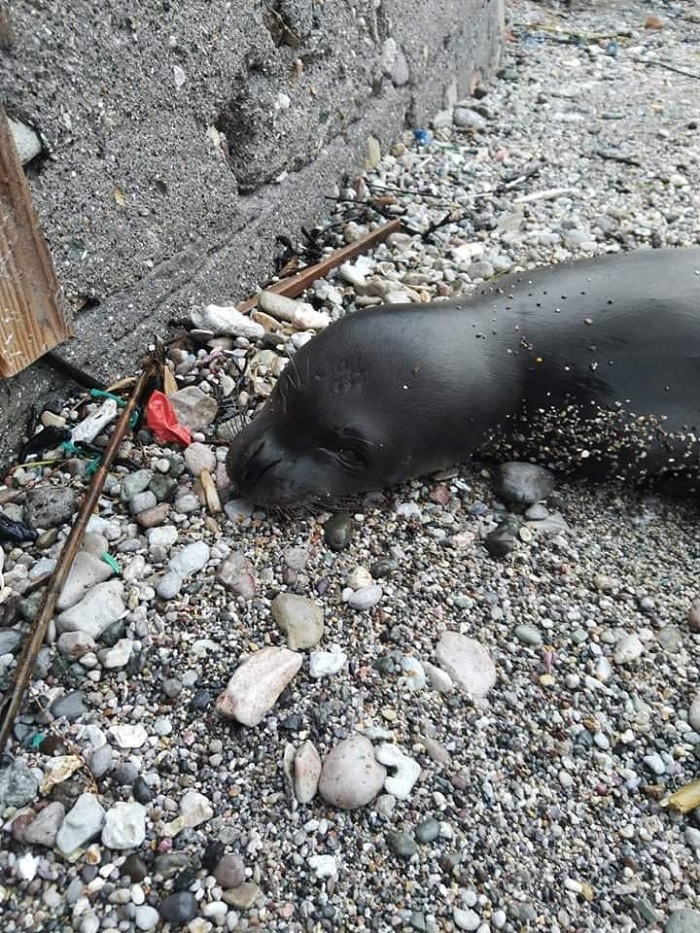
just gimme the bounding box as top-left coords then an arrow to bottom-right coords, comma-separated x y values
0,0 -> 700,933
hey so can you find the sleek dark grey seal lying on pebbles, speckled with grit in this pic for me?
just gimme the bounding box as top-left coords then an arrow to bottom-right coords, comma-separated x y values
227,248 -> 700,507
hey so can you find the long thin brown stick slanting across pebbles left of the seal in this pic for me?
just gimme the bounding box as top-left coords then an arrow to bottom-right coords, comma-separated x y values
0,356 -> 159,755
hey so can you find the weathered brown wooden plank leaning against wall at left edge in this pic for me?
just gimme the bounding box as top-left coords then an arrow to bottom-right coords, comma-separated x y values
0,107 -> 73,379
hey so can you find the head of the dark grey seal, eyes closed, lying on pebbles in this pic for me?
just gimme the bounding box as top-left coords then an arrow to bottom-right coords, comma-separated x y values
226,311 -> 474,507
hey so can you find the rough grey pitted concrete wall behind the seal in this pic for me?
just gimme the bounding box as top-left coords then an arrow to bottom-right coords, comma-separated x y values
0,0 -> 503,461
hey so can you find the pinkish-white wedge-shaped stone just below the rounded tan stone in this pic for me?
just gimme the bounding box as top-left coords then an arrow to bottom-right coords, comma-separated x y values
216,648 -> 302,726
